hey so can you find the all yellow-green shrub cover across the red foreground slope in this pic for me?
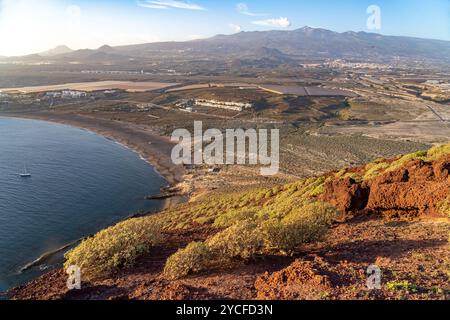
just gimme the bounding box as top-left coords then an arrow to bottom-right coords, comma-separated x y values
65,145 -> 450,280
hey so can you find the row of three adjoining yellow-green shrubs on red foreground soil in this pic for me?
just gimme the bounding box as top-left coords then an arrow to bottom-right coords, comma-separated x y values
164,202 -> 338,279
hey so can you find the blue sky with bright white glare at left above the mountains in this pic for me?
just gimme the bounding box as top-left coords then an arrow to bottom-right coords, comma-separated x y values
0,0 -> 450,56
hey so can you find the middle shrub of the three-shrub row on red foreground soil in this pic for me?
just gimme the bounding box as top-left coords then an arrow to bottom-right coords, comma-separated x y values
206,221 -> 264,259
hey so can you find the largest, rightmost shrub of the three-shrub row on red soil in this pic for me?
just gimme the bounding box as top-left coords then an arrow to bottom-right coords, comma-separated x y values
264,202 -> 337,251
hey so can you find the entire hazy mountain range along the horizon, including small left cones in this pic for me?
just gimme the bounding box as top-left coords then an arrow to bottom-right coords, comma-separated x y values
3,27 -> 450,64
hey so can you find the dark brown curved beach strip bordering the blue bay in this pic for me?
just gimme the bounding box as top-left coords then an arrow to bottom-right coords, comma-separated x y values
0,112 -> 185,187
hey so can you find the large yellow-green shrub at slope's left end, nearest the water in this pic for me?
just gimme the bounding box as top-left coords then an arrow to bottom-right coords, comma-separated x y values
64,218 -> 162,280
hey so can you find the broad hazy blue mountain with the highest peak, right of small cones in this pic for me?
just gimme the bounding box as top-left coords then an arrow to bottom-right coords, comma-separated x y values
111,27 -> 450,62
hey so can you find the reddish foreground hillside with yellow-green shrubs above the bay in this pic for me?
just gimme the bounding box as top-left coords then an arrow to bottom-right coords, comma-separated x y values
10,144 -> 450,299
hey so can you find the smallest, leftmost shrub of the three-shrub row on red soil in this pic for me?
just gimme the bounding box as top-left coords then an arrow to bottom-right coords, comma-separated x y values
164,242 -> 211,280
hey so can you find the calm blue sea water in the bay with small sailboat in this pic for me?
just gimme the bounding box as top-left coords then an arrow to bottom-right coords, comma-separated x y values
0,117 -> 167,291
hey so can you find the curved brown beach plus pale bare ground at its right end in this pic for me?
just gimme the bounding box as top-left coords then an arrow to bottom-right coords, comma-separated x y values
0,112 -> 297,207
